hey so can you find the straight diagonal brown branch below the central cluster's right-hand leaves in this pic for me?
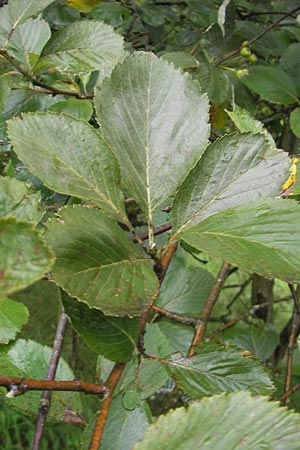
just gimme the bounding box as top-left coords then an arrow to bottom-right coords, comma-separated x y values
188,262 -> 230,358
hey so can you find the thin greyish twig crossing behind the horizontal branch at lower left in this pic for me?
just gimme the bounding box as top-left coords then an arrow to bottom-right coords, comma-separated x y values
31,311 -> 68,450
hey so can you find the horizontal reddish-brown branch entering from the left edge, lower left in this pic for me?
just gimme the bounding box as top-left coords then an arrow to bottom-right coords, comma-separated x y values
0,375 -> 107,397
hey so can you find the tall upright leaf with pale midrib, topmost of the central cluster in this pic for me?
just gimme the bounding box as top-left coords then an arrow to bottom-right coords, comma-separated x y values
95,53 -> 209,222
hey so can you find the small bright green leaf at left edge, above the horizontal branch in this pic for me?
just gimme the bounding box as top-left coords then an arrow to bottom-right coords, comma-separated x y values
0,298 -> 28,344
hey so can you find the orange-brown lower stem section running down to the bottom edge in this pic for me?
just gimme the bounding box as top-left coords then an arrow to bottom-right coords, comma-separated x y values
89,363 -> 125,450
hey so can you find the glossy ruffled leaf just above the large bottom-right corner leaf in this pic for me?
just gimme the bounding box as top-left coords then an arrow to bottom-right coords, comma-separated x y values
168,343 -> 273,398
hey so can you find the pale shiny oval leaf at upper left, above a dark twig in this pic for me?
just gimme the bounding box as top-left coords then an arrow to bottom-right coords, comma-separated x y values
40,20 -> 124,79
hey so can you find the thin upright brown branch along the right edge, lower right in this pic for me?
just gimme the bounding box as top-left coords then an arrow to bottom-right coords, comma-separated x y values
283,283 -> 300,405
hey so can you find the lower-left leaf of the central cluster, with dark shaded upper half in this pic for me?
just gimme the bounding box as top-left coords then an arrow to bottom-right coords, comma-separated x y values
46,206 -> 157,316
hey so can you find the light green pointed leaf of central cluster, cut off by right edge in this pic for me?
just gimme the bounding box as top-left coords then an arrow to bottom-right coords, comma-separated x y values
181,199 -> 300,282
